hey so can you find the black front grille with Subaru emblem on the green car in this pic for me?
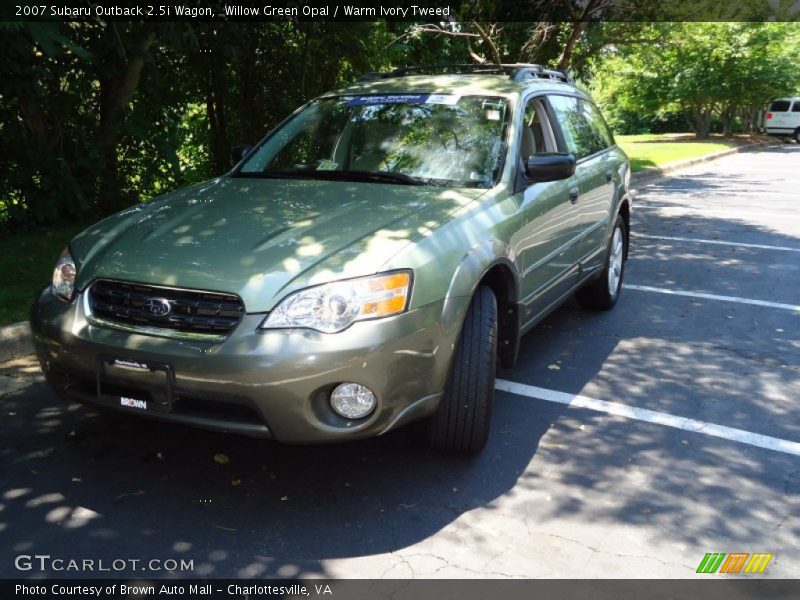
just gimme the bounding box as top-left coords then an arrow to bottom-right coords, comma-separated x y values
89,279 -> 244,335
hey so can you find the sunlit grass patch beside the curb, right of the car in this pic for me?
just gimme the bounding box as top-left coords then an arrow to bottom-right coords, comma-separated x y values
614,133 -> 755,173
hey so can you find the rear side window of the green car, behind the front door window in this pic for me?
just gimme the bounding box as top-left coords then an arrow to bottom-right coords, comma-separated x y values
548,96 -> 612,160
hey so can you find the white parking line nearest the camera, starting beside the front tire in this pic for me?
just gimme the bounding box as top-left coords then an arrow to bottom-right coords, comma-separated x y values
495,379 -> 800,456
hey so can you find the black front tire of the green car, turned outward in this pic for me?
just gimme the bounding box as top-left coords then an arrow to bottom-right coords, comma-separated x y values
428,287 -> 497,455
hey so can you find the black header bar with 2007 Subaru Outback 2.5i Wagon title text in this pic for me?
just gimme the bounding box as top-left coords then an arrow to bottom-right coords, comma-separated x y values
0,0 -> 800,22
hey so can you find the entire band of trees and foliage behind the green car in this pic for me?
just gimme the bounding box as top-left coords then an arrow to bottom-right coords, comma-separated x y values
0,19 -> 800,229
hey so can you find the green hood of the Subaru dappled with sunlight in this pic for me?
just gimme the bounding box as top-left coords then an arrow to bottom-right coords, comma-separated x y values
70,177 -> 486,312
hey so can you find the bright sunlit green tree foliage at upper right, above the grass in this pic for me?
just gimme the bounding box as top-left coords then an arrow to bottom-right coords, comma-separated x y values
591,23 -> 800,138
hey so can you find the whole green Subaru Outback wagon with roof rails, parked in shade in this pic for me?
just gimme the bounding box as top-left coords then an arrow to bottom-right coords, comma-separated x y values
31,65 -> 630,453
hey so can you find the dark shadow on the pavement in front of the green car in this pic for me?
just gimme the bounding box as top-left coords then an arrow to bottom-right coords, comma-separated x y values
0,384 -> 557,577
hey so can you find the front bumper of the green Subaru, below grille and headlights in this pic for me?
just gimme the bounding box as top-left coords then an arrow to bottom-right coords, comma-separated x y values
31,289 -> 468,443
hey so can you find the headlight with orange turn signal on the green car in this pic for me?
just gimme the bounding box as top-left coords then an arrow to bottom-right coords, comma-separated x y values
261,271 -> 411,333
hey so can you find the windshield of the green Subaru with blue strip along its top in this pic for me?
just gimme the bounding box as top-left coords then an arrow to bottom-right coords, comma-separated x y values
235,94 -> 508,187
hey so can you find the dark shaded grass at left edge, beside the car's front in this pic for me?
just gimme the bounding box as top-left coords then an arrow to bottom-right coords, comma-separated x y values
0,223 -> 86,325
